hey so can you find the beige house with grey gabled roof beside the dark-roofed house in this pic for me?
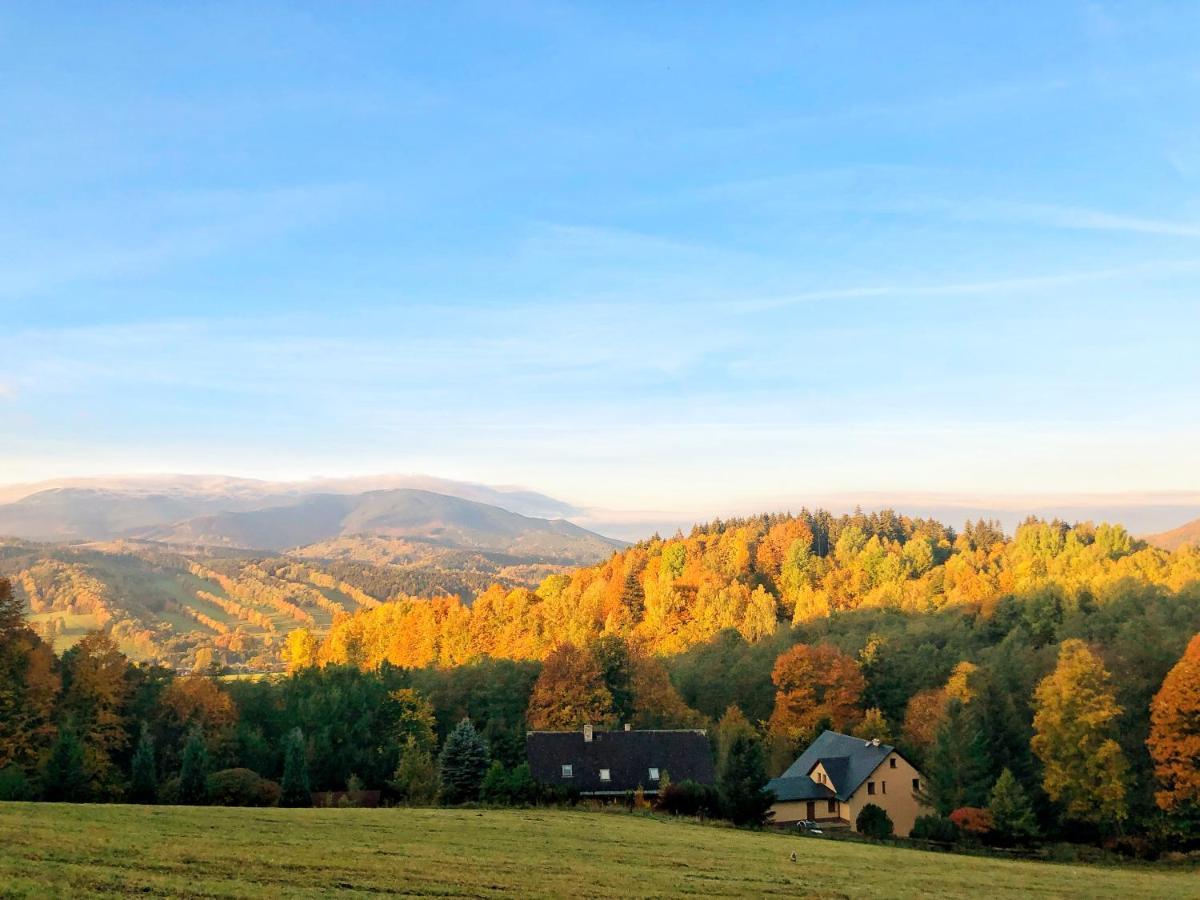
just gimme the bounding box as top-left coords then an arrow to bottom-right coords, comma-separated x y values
767,731 -> 930,838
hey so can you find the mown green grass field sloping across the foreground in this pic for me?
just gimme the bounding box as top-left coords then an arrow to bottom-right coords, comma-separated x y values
0,803 -> 1200,899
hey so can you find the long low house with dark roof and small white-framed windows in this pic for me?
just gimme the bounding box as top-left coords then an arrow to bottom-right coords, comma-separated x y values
526,725 -> 715,798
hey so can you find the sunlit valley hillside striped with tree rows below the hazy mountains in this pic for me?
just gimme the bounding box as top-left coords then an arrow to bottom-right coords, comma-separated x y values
0,536 -> 578,672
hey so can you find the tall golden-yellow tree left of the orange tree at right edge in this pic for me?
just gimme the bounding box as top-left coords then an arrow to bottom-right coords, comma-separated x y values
1032,640 -> 1129,827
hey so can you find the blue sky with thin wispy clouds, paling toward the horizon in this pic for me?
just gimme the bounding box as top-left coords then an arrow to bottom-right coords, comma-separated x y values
0,2 -> 1200,514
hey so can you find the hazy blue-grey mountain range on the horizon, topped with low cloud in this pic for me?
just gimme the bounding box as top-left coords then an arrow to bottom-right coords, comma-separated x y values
0,478 -> 624,564
